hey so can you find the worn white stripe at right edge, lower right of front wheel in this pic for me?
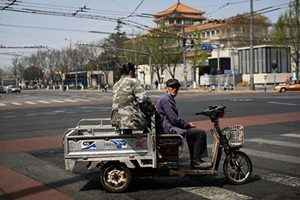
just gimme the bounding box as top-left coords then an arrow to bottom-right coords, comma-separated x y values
260,173 -> 300,187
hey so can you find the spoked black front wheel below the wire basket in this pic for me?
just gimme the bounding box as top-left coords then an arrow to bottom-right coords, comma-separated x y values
223,151 -> 252,185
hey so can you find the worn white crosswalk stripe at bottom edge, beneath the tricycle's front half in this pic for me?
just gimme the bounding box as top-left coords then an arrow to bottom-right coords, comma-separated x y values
180,186 -> 253,200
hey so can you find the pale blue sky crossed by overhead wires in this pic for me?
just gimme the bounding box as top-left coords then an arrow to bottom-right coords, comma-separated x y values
0,0 -> 290,68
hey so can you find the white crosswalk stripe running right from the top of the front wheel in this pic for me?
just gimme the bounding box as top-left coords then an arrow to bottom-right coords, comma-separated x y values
242,148 -> 300,164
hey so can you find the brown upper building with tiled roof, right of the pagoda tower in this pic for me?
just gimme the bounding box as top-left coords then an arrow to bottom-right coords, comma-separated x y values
185,15 -> 270,48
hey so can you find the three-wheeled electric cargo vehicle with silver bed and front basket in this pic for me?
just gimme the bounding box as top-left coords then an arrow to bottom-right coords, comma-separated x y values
64,105 -> 252,192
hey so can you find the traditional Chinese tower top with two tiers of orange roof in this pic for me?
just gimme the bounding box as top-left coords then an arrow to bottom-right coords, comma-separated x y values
154,0 -> 206,29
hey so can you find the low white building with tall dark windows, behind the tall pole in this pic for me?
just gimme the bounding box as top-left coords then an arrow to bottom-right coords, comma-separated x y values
198,45 -> 291,85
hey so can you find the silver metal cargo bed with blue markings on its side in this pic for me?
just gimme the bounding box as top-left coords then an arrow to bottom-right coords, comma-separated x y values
64,118 -> 156,170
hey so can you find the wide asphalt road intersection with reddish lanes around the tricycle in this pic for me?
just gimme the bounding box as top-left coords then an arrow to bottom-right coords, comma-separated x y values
0,91 -> 300,200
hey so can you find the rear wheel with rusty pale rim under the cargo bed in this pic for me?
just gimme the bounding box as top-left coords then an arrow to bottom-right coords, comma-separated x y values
100,163 -> 132,193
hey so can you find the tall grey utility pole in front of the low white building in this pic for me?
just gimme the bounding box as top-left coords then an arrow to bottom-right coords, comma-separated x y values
250,0 -> 255,90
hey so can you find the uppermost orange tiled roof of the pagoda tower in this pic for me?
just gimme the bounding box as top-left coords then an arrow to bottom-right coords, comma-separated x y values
154,3 -> 204,18
